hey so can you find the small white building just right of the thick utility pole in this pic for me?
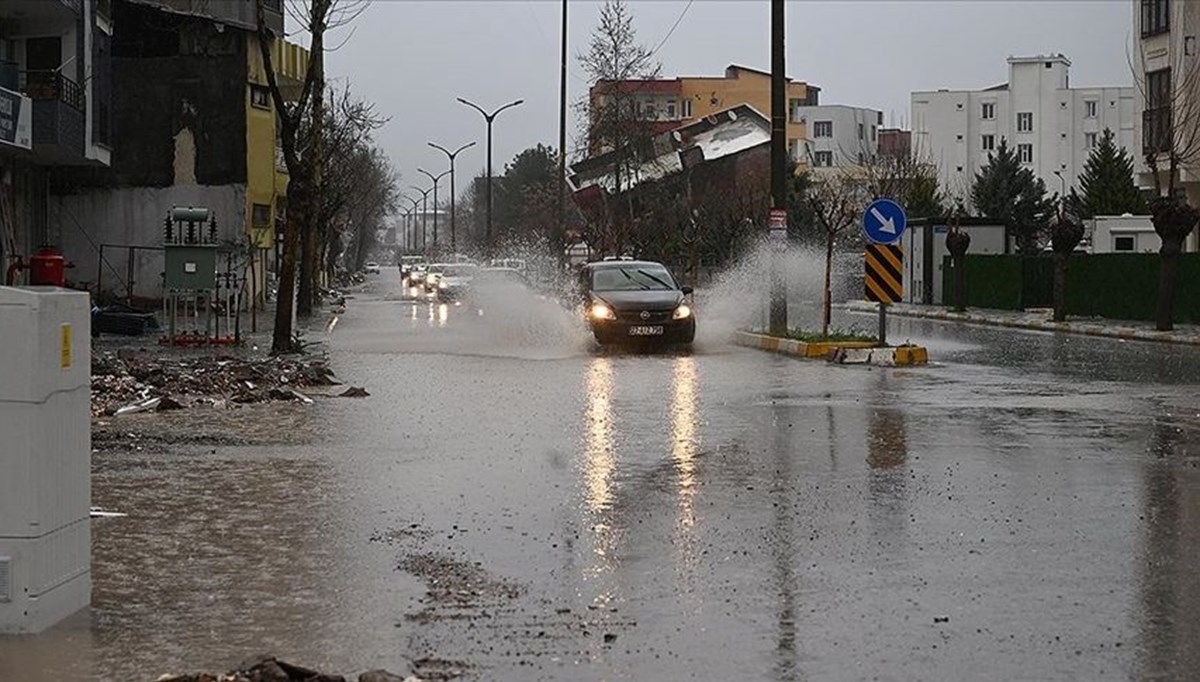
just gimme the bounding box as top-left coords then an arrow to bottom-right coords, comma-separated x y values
788,104 -> 883,168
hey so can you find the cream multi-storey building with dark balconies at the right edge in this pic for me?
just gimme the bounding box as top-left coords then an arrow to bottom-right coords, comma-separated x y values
1132,0 -> 1200,210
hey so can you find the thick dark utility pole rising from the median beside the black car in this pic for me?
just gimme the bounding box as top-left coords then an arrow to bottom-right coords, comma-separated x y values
769,0 -> 788,335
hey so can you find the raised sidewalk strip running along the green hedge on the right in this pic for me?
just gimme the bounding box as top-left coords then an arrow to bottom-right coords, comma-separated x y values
842,301 -> 1200,346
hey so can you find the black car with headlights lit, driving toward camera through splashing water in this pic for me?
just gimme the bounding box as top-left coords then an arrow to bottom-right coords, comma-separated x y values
580,259 -> 696,345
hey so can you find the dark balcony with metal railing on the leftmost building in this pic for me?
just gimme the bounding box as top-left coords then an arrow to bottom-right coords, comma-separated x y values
20,71 -> 86,164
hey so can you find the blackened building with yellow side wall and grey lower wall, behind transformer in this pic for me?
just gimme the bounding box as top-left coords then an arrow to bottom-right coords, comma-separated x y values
48,0 -> 308,301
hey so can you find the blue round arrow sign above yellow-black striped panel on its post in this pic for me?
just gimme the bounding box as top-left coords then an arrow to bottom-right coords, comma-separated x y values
863,199 -> 908,346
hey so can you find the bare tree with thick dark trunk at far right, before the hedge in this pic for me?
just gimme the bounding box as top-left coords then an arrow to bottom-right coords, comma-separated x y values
1130,31 -> 1200,331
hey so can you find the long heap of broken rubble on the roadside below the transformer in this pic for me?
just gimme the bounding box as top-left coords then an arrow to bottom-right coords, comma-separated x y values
91,351 -> 338,417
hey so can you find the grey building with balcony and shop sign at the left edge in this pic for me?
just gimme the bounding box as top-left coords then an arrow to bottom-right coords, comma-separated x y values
0,0 -> 113,282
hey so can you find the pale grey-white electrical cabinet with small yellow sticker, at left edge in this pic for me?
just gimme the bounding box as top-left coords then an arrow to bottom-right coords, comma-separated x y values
0,287 -> 91,633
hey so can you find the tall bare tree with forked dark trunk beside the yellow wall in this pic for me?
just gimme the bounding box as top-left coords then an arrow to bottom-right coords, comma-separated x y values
254,0 -> 366,353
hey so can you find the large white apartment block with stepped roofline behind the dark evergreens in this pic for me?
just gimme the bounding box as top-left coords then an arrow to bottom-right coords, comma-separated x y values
912,54 -> 1139,204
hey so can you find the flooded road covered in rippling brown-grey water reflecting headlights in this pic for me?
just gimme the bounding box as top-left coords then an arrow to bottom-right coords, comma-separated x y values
0,276 -> 1200,682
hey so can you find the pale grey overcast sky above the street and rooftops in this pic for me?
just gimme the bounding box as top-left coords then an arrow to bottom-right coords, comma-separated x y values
316,0 -> 1133,201
